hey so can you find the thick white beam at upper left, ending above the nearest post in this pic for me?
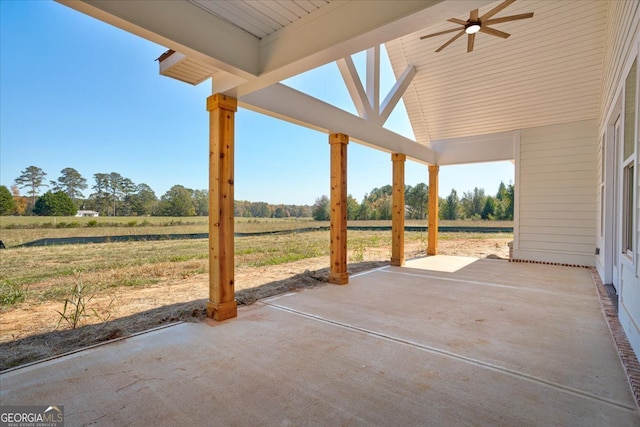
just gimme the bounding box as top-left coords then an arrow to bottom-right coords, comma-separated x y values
57,0 -> 260,79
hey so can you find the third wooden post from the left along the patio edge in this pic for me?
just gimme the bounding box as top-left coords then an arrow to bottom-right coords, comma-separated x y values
391,153 -> 407,266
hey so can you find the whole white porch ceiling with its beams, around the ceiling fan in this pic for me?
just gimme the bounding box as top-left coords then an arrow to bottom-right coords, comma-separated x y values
58,0 -> 607,164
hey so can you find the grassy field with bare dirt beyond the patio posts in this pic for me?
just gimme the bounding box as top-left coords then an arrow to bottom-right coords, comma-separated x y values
0,217 -> 513,369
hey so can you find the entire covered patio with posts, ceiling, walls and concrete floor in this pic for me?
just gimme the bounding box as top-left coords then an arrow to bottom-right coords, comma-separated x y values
6,0 -> 640,426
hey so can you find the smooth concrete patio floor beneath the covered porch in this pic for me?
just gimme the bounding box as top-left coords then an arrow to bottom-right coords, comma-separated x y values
0,256 -> 640,427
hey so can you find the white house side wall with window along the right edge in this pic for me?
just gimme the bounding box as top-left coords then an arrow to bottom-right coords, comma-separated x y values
597,1 -> 640,362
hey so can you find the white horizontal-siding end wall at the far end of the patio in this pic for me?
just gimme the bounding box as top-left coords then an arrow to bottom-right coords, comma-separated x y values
513,119 -> 598,266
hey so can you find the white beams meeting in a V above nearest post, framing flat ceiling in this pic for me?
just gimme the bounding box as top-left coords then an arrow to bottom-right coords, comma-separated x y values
57,0 -> 489,97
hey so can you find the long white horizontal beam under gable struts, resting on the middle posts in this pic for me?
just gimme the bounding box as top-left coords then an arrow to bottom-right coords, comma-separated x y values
238,84 -> 436,164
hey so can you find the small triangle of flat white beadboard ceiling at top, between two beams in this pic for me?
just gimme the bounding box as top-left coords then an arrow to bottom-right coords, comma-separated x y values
189,0 -> 332,39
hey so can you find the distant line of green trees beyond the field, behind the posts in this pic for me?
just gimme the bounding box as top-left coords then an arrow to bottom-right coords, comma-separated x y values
0,166 -> 514,221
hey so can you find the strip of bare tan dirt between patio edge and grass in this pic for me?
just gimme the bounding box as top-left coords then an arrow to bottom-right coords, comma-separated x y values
0,238 -> 510,370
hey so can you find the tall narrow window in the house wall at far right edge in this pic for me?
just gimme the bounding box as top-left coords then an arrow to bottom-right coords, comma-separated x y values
622,60 -> 638,256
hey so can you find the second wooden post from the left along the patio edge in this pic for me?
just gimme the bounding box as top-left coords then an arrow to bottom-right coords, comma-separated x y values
329,133 -> 349,285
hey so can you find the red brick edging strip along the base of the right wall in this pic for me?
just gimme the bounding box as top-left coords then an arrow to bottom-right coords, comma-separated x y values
591,267 -> 640,409
